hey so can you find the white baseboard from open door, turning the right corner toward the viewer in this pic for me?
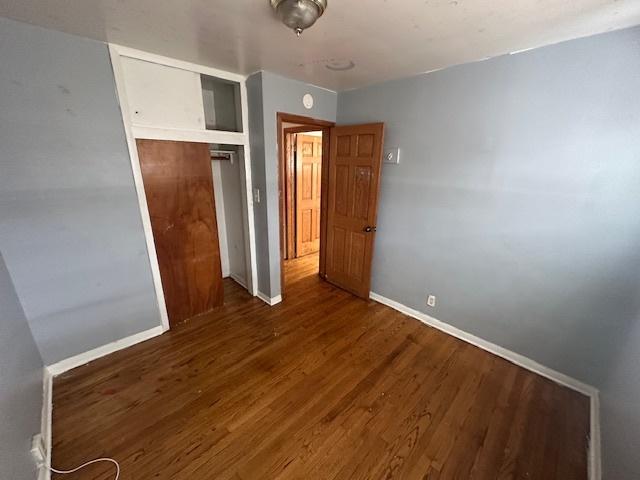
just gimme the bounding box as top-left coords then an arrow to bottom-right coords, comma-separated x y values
369,292 -> 602,480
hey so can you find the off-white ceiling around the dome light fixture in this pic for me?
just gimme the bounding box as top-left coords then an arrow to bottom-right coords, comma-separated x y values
0,0 -> 640,91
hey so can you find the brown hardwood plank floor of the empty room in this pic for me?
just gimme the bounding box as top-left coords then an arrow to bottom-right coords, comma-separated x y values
53,256 -> 589,480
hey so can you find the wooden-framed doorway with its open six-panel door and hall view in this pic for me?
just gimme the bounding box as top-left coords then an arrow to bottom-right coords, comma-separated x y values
277,113 -> 384,299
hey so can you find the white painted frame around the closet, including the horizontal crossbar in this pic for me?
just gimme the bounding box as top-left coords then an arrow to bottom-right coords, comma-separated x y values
109,44 -> 258,331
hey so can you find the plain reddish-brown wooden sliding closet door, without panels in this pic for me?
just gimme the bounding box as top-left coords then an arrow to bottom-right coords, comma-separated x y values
136,140 -> 224,325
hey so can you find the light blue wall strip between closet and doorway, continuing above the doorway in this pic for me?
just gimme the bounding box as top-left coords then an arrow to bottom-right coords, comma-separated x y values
247,72 -> 338,297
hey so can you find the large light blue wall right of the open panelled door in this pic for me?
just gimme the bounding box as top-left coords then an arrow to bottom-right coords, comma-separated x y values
338,24 -> 640,480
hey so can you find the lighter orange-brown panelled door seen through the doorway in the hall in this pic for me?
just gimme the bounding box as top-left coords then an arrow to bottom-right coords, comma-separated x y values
295,133 -> 322,257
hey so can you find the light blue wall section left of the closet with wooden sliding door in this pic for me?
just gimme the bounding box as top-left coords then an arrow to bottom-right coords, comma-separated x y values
0,19 -> 161,364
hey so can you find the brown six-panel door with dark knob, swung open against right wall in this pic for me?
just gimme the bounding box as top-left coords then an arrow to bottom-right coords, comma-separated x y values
325,123 -> 384,298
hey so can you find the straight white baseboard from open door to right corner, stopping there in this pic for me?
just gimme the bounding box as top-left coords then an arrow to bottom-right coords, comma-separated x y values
369,292 -> 598,397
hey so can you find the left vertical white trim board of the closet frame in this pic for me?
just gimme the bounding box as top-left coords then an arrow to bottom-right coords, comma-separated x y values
109,45 -> 169,331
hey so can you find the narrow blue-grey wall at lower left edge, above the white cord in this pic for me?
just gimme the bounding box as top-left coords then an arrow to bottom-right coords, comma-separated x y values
0,253 -> 42,480
